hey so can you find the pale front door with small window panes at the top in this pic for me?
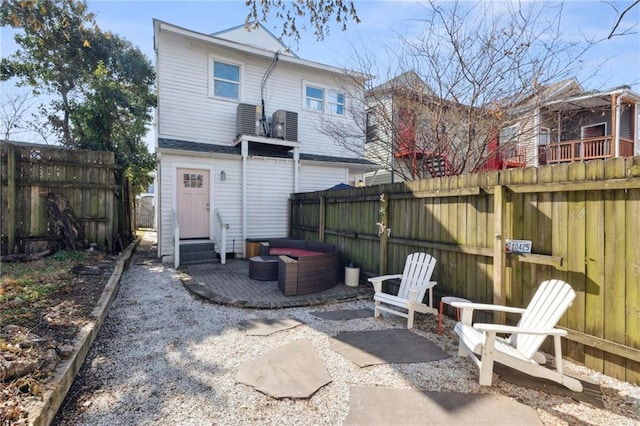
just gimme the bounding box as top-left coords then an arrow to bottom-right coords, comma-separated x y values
176,169 -> 209,239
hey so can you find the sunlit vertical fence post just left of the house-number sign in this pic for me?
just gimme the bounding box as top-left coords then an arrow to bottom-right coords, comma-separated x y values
493,185 -> 507,323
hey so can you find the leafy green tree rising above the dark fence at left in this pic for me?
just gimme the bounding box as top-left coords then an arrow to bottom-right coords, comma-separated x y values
0,0 -> 156,192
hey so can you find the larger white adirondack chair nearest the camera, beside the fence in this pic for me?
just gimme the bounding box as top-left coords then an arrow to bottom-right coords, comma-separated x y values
452,280 -> 582,392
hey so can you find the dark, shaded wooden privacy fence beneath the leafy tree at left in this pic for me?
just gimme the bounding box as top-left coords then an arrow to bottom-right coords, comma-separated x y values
0,142 -> 133,255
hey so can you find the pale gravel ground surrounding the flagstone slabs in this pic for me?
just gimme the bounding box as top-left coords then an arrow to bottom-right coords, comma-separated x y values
54,241 -> 640,426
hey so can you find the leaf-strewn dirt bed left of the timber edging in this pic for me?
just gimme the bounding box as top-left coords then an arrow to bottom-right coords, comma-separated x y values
0,251 -> 117,425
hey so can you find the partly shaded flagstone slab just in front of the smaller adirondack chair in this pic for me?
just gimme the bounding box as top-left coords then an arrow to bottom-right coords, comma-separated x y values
330,329 -> 449,367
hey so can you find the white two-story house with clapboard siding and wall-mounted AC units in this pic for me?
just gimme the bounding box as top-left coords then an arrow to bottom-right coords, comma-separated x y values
153,20 -> 372,262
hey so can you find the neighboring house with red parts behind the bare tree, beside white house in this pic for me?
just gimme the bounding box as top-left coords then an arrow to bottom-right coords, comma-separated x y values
366,71 -> 486,185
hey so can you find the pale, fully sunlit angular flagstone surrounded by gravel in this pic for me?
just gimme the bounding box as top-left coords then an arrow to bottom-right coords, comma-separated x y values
236,339 -> 331,399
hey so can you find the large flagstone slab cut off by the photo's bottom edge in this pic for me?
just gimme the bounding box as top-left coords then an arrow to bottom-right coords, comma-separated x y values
344,386 -> 543,426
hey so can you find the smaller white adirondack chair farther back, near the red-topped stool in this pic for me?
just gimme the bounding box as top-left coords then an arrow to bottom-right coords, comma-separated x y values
369,253 -> 438,328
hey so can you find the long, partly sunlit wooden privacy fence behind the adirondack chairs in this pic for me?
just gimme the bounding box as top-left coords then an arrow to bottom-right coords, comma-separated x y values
289,157 -> 640,384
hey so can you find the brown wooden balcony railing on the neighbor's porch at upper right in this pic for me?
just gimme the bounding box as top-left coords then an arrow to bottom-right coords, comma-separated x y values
538,136 -> 633,165
